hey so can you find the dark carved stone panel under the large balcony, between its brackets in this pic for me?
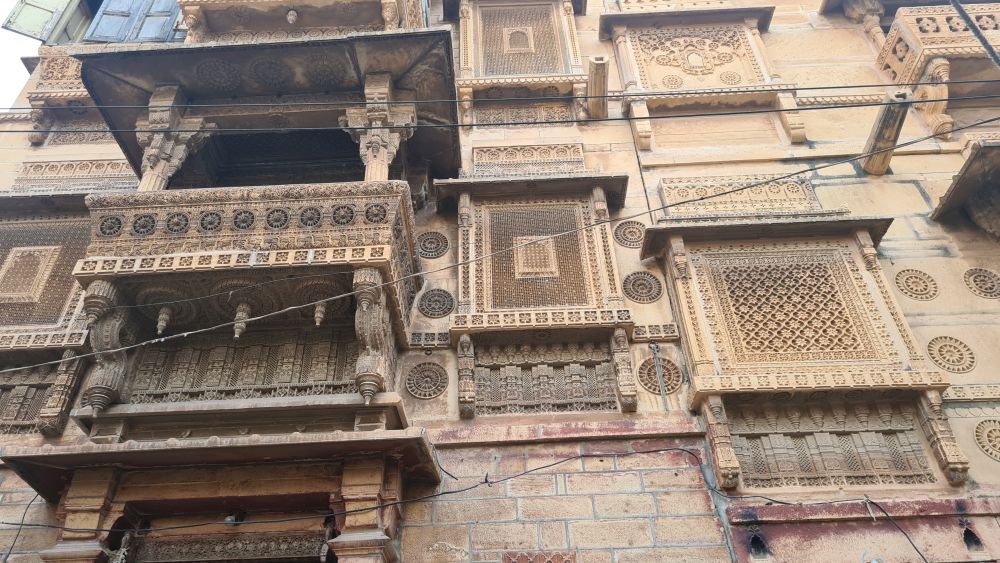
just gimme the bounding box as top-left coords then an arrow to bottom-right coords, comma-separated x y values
128,331 -> 358,403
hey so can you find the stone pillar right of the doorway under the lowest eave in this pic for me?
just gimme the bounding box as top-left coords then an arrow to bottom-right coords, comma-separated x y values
327,457 -> 402,563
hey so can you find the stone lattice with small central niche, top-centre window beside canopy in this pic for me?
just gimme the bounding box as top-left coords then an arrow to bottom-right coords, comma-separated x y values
480,4 -> 566,76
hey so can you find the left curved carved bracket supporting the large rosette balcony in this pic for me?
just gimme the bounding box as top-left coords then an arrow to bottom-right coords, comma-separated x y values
83,280 -> 138,413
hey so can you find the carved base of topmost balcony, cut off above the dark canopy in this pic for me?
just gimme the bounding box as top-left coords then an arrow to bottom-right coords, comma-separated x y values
179,0 -> 427,43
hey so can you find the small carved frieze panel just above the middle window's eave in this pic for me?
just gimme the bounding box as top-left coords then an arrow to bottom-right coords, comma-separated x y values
472,144 -> 587,176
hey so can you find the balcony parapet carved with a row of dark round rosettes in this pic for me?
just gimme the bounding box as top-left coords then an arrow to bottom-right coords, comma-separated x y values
74,181 -> 419,338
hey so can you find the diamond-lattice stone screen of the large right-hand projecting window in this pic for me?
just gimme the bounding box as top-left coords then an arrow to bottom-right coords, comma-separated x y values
699,250 -> 881,363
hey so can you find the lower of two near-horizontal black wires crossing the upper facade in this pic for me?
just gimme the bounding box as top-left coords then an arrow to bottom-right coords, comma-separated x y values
0,94 -> 1000,134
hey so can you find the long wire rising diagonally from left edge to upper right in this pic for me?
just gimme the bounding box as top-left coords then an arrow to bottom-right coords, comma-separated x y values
0,112 -> 1000,374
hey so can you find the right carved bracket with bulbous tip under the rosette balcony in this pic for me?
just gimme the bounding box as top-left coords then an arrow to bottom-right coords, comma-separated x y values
354,268 -> 394,405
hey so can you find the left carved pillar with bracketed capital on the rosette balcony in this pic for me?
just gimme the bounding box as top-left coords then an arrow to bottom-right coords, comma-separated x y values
135,86 -> 215,191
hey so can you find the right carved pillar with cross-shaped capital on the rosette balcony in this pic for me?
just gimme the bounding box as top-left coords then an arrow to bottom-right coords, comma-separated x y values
346,71 -> 417,181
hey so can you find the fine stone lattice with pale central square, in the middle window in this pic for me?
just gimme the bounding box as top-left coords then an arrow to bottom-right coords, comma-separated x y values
489,205 -> 592,309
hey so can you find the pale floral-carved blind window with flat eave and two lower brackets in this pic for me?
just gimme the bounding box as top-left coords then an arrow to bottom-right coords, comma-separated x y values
600,7 -> 806,150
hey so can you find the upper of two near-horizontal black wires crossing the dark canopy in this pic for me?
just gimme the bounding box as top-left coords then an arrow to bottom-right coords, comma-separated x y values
0,78 -> 1000,111
